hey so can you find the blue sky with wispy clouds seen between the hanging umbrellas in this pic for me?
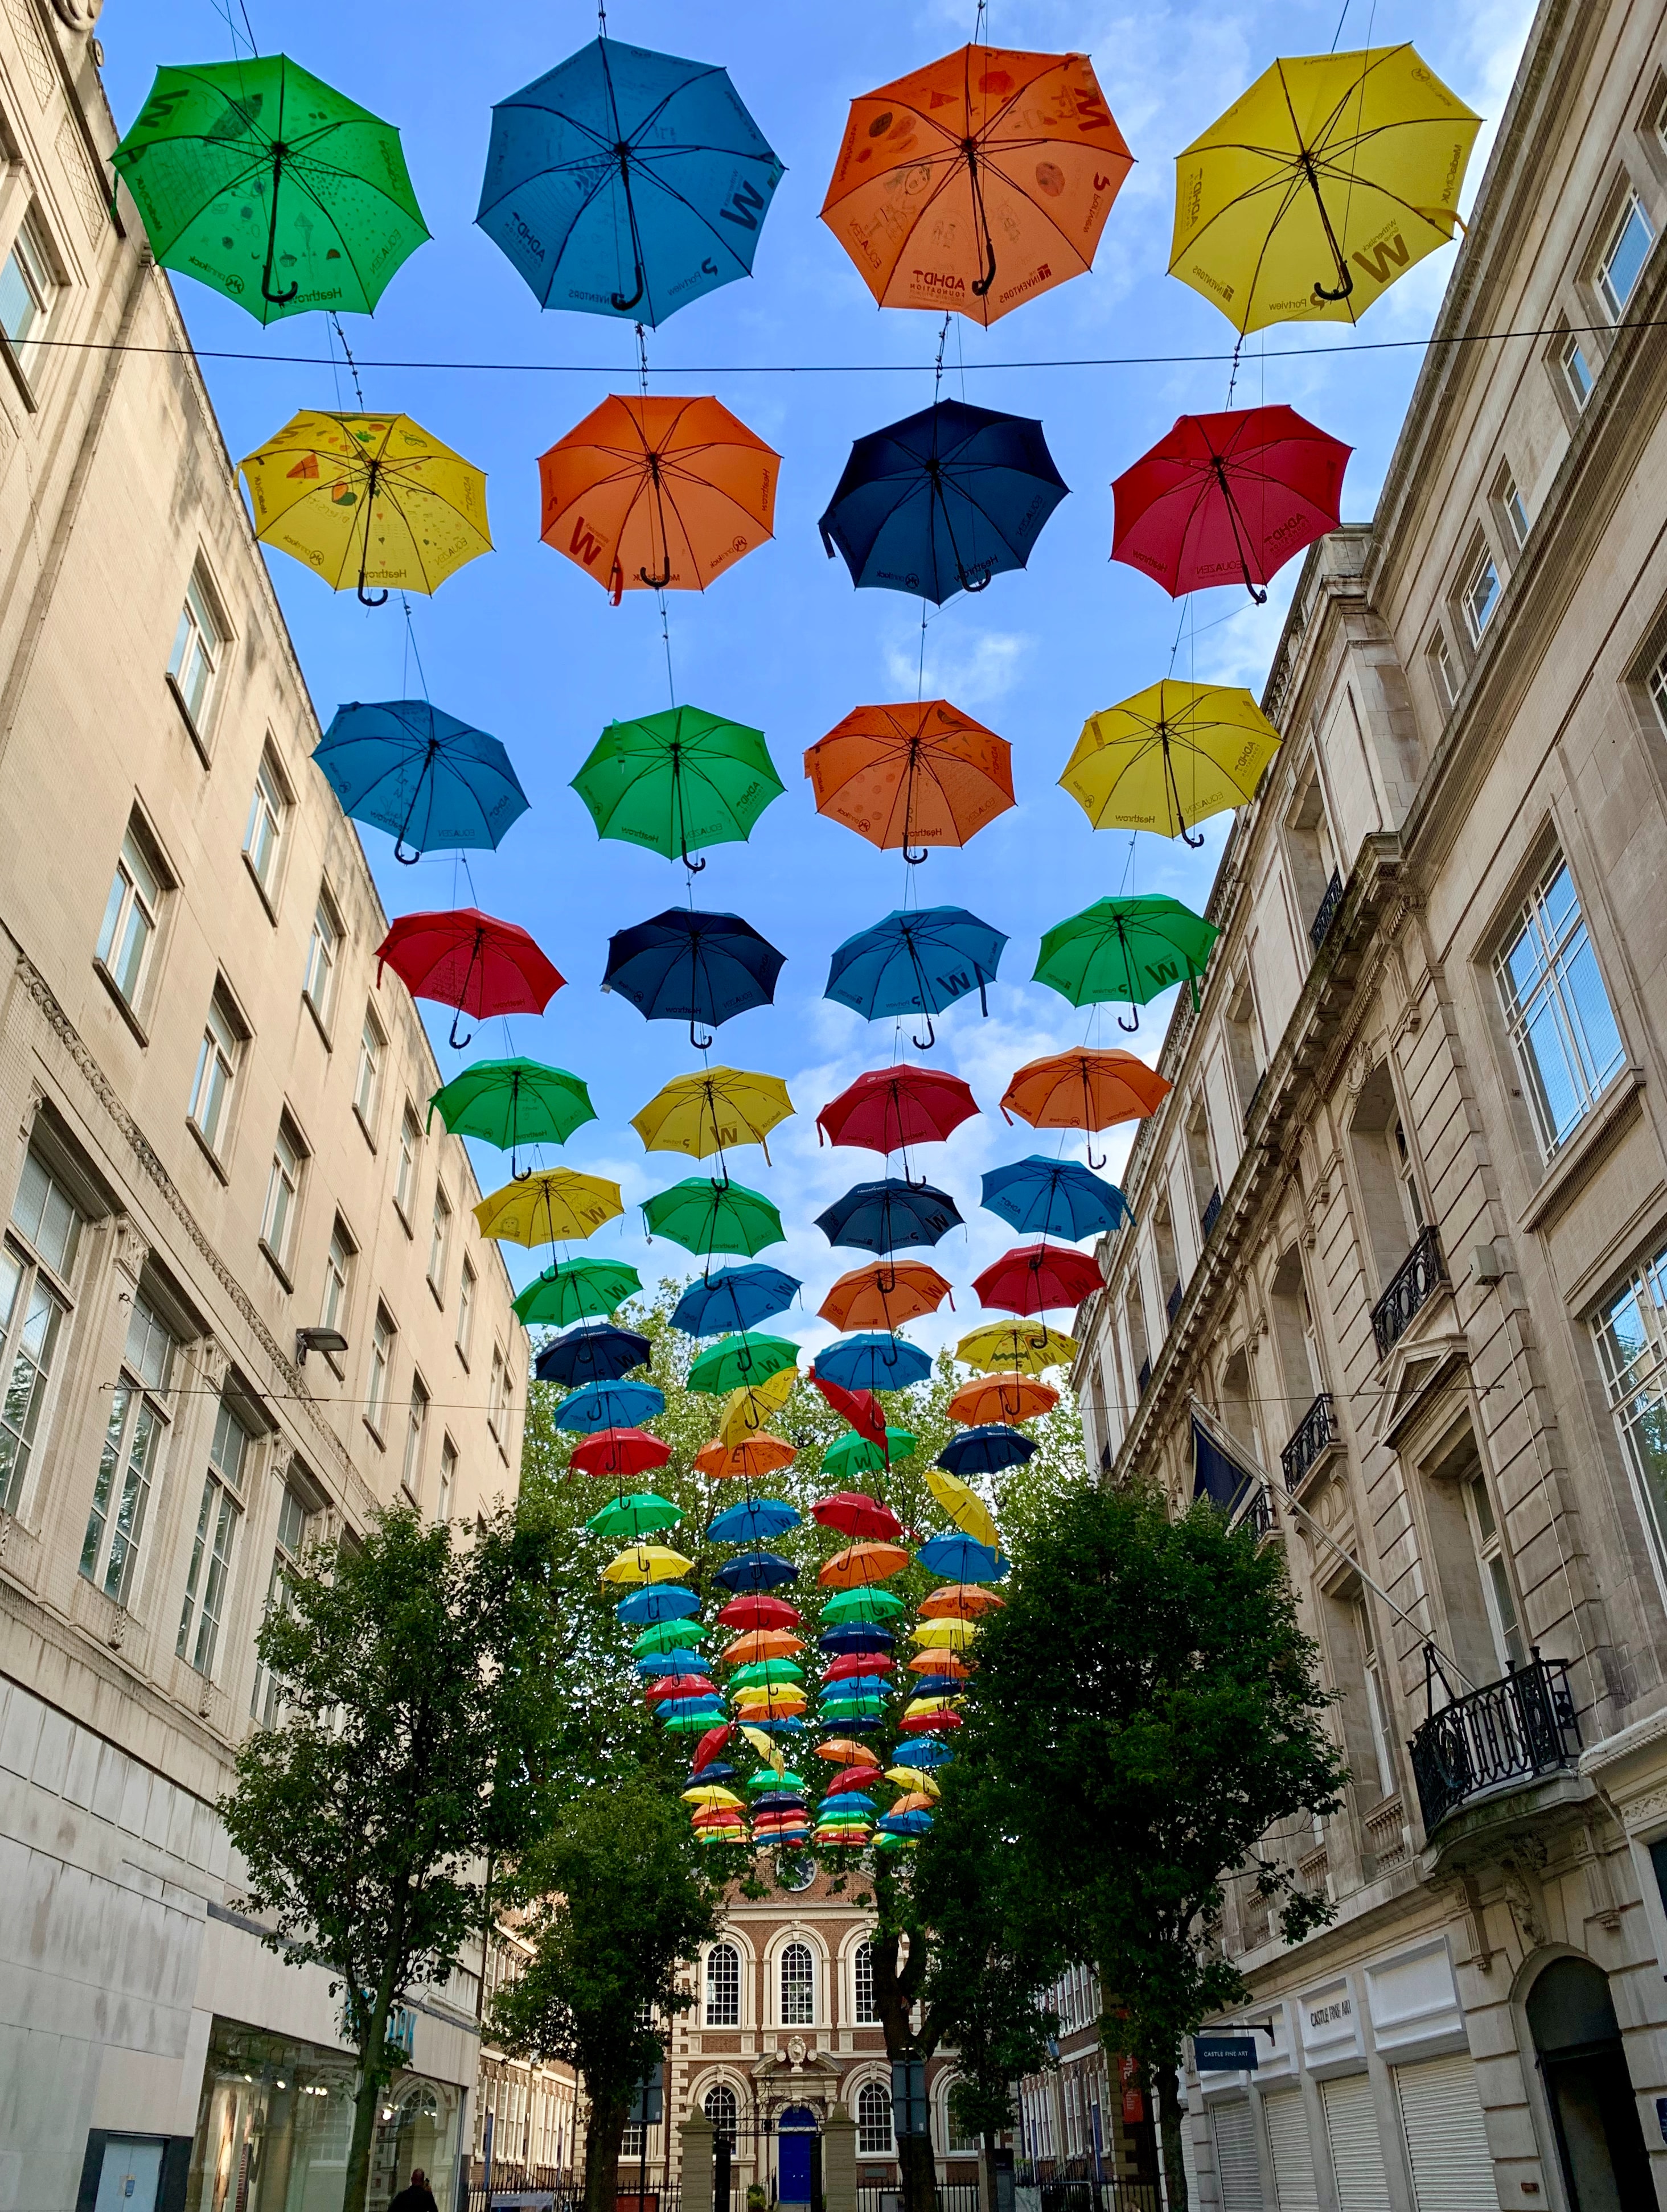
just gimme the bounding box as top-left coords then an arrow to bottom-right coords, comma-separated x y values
100,0 -> 1532,1345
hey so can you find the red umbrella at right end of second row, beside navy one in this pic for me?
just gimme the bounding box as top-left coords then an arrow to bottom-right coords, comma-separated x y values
1111,407 -> 1353,602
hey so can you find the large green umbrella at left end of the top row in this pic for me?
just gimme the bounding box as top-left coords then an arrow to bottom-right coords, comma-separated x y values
110,53 -> 427,323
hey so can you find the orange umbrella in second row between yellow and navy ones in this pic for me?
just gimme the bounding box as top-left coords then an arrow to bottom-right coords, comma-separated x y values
538,394 -> 782,606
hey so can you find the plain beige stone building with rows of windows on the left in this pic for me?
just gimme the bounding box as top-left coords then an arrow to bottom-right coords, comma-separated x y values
0,0 -> 525,2212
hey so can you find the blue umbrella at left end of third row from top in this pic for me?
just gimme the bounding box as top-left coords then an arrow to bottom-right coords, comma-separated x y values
312,699 -> 527,867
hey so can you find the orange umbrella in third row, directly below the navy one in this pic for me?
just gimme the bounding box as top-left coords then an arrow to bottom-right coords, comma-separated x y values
804,699 -> 1014,861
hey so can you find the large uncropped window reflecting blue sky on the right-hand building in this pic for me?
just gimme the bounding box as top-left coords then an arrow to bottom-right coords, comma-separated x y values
1497,854 -> 1627,1159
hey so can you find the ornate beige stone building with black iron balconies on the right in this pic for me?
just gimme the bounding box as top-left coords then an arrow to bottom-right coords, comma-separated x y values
1078,0 -> 1667,2212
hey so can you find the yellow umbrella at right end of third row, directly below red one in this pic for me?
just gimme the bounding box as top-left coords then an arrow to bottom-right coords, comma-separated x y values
1058,679 -> 1280,845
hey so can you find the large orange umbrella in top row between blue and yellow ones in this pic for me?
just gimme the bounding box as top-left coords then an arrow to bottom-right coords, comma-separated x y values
822,47 -> 1134,325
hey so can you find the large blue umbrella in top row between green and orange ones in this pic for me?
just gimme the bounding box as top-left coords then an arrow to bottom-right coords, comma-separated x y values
476,38 -> 782,327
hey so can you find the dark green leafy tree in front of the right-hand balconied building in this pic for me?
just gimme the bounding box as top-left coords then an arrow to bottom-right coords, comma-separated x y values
952,1489 -> 1346,2205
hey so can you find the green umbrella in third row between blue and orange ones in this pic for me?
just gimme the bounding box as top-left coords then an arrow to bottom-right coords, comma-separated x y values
573,706 -> 782,869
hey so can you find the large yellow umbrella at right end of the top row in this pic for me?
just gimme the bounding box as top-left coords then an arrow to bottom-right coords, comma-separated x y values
1169,47 -> 1481,332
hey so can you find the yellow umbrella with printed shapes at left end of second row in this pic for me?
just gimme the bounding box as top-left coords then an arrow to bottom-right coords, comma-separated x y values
239,407 -> 491,606
